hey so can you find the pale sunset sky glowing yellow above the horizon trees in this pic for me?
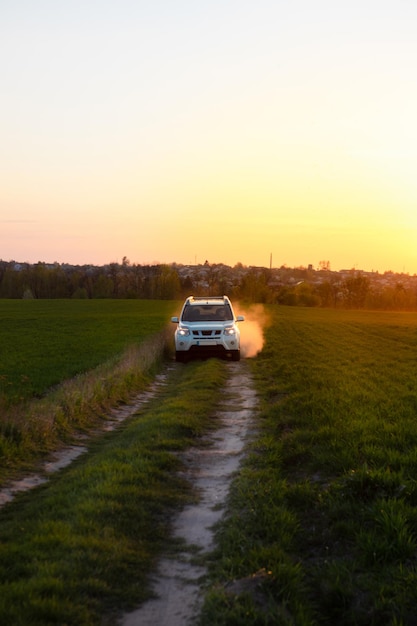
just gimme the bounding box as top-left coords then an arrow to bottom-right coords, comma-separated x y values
0,0 -> 417,274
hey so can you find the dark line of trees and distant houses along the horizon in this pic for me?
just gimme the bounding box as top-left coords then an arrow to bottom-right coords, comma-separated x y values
0,258 -> 417,310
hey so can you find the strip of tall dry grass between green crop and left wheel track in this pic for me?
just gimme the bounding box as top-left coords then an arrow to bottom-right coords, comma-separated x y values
0,330 -> 172,483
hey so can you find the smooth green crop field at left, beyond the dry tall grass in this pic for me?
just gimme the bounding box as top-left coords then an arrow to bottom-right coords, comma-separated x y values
0,299 -> 173,406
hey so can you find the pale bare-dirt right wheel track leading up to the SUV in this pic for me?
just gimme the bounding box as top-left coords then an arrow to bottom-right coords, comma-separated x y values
119,361 -> 257,626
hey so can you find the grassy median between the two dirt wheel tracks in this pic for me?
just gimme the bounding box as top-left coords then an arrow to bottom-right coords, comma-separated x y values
0,361 -> 226,626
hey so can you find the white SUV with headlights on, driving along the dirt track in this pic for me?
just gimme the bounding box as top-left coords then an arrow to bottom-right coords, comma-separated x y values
171,296 -> 245,362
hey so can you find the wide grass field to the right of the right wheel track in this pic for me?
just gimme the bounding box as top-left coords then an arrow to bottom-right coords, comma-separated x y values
201,307 -> 417,626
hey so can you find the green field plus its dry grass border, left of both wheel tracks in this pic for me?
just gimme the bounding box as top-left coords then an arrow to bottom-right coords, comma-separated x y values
0,300 -> 175,476
